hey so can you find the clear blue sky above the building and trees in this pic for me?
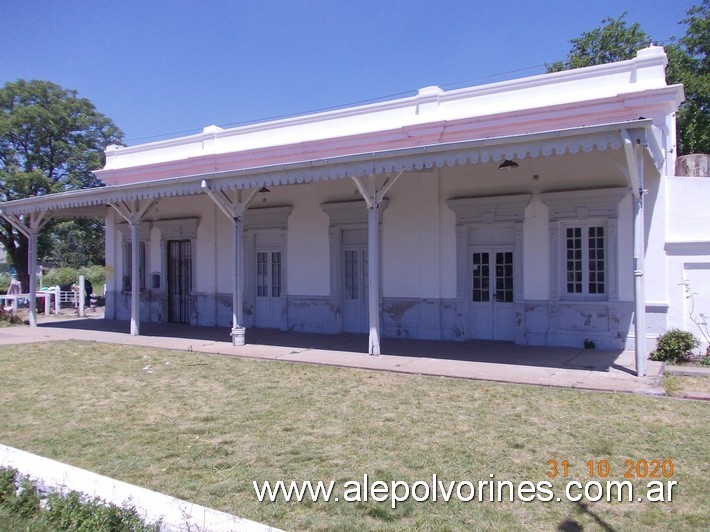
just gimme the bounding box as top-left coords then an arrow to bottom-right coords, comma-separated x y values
0,0 -> 699,145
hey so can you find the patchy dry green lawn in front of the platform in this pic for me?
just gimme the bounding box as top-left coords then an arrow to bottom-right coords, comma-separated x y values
0,342 -> 710,530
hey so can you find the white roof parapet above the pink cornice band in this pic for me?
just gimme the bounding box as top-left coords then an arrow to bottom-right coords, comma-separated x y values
104,46 -> 680,181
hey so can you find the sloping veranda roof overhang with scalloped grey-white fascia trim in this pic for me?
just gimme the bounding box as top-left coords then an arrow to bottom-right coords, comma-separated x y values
0,119 -> 663,216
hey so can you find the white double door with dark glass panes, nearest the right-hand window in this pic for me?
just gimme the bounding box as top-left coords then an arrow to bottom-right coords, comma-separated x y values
468,246 -> 515,340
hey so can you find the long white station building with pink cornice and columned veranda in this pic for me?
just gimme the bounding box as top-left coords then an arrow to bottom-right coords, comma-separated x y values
0,47 -> 710,373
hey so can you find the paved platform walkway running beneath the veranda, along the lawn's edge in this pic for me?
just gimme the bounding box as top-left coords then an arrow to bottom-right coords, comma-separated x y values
0,317 -> 663,395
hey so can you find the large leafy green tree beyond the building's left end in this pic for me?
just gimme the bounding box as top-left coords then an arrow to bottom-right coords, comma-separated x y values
0,80 -> 123,286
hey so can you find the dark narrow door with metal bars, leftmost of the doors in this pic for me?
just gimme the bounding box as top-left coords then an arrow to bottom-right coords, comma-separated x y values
167,240 -> 192,323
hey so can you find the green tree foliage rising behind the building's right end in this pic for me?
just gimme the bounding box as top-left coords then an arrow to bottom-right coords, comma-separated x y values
546,6 -> 710,155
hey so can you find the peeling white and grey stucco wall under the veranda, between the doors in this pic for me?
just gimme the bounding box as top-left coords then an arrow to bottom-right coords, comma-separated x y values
107,157 -> 662,347
